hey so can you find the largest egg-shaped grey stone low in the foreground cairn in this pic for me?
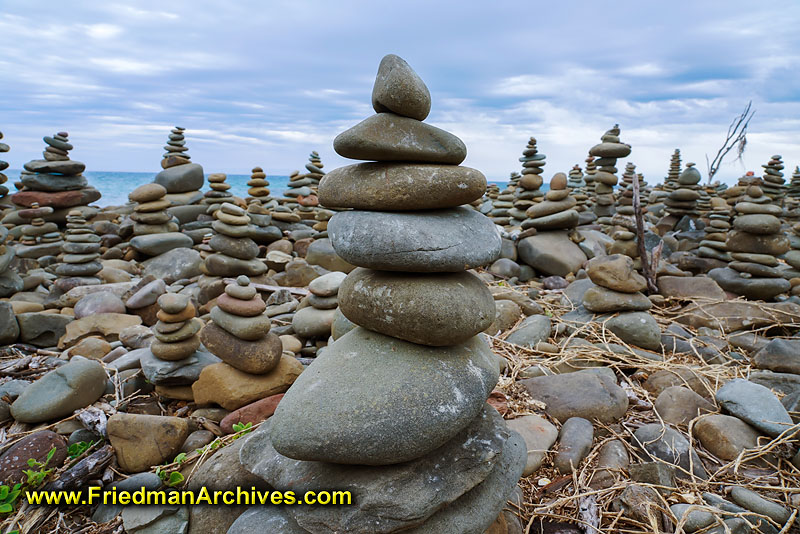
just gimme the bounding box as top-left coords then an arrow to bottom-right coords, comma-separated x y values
271,328 -> 499,465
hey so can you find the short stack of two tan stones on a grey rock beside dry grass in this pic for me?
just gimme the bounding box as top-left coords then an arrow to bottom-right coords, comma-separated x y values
583,254 -> 661,350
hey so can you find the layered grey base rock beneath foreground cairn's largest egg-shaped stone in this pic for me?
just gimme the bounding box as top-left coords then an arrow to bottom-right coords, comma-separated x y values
239,408 -> 509,534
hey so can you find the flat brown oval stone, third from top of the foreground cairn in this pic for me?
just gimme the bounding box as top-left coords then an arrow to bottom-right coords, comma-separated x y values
319,163 -> 486,211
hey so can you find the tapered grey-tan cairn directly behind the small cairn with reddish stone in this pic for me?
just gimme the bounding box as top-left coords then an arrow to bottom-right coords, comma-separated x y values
201,202 -> 267,276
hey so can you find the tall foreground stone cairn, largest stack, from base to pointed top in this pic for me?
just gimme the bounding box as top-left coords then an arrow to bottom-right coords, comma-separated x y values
240,55 -> 526,534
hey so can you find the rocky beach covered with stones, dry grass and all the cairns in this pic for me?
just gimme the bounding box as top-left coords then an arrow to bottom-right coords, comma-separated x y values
0,55 -> 800,534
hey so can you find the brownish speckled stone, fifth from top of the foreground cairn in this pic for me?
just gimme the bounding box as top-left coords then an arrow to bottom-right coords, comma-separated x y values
339,267 -> 495,347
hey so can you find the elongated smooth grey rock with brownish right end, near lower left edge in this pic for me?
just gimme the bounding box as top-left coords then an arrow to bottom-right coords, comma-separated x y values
11,356 -> 107,423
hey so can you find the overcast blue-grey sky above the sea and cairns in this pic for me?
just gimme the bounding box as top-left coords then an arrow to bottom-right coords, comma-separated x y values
0,0 -> 800,182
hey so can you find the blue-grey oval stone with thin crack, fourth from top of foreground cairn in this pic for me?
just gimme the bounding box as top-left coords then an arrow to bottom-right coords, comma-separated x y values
328,207 -> 501,272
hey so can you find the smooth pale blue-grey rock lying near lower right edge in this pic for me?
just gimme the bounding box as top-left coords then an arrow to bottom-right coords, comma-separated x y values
716,378 -> 793,437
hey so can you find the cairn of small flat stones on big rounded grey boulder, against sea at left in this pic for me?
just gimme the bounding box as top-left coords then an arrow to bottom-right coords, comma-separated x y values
153,126 -> 205,205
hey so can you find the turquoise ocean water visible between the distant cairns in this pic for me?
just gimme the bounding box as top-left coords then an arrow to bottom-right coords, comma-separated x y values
5,170 -> 507,206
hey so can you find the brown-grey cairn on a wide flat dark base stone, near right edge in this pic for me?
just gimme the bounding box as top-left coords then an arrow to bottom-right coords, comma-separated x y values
708,185 -> 791,300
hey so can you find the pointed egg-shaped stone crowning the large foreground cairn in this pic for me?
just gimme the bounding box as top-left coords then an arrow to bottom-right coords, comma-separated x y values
372,54 -> 431,121
